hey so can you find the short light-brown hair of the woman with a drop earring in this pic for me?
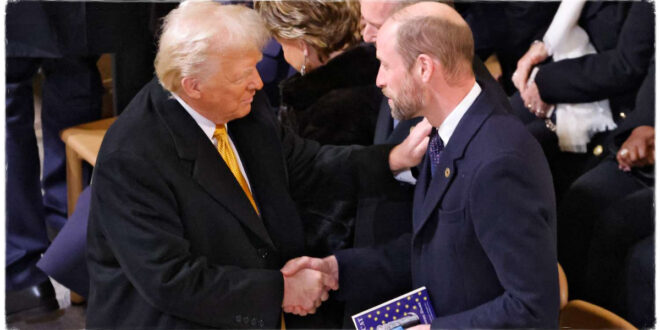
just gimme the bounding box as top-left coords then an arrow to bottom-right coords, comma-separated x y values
254,0 -> 361,61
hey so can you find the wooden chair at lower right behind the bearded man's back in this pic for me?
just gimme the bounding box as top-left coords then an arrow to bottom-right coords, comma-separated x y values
557,264 -> 637,329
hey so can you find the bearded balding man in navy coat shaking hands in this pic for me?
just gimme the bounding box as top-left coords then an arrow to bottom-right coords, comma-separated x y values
282,2 -> 559,329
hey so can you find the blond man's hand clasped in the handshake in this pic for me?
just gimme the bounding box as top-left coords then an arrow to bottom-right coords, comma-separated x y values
281,257 -> 339,316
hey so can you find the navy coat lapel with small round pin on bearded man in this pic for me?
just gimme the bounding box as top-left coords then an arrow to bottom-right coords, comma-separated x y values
413,84 -> 493,235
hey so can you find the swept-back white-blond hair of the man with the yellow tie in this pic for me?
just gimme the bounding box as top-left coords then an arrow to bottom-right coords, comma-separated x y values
154,1 -> 270,93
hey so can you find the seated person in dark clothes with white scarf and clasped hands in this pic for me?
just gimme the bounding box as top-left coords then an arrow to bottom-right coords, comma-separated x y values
511,1 -> 655,196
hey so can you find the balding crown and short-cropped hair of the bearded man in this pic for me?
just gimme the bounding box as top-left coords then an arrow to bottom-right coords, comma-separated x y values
378,2 -> 474,81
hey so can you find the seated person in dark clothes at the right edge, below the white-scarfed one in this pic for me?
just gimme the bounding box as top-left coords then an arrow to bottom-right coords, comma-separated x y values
557,56 -> 655,322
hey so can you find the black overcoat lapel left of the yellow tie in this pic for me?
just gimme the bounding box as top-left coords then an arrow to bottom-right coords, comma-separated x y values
156,83 -> 275,249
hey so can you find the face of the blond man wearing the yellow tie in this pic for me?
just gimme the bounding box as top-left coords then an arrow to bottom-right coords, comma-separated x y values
195,48 -> 263,124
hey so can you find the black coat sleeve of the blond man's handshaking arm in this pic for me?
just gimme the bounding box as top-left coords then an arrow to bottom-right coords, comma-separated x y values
89,152 -> 284,328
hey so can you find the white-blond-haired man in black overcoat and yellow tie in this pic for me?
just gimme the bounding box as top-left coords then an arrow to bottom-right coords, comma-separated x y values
87,1 -> 428,329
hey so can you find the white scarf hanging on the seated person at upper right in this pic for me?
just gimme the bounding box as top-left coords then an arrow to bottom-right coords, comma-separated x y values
543,0 -> 616,153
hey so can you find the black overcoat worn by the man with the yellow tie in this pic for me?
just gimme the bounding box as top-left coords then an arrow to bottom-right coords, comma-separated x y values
87,80 -> 389,328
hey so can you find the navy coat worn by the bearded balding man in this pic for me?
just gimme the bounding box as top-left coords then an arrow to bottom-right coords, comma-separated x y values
337,82 -> 559,328
